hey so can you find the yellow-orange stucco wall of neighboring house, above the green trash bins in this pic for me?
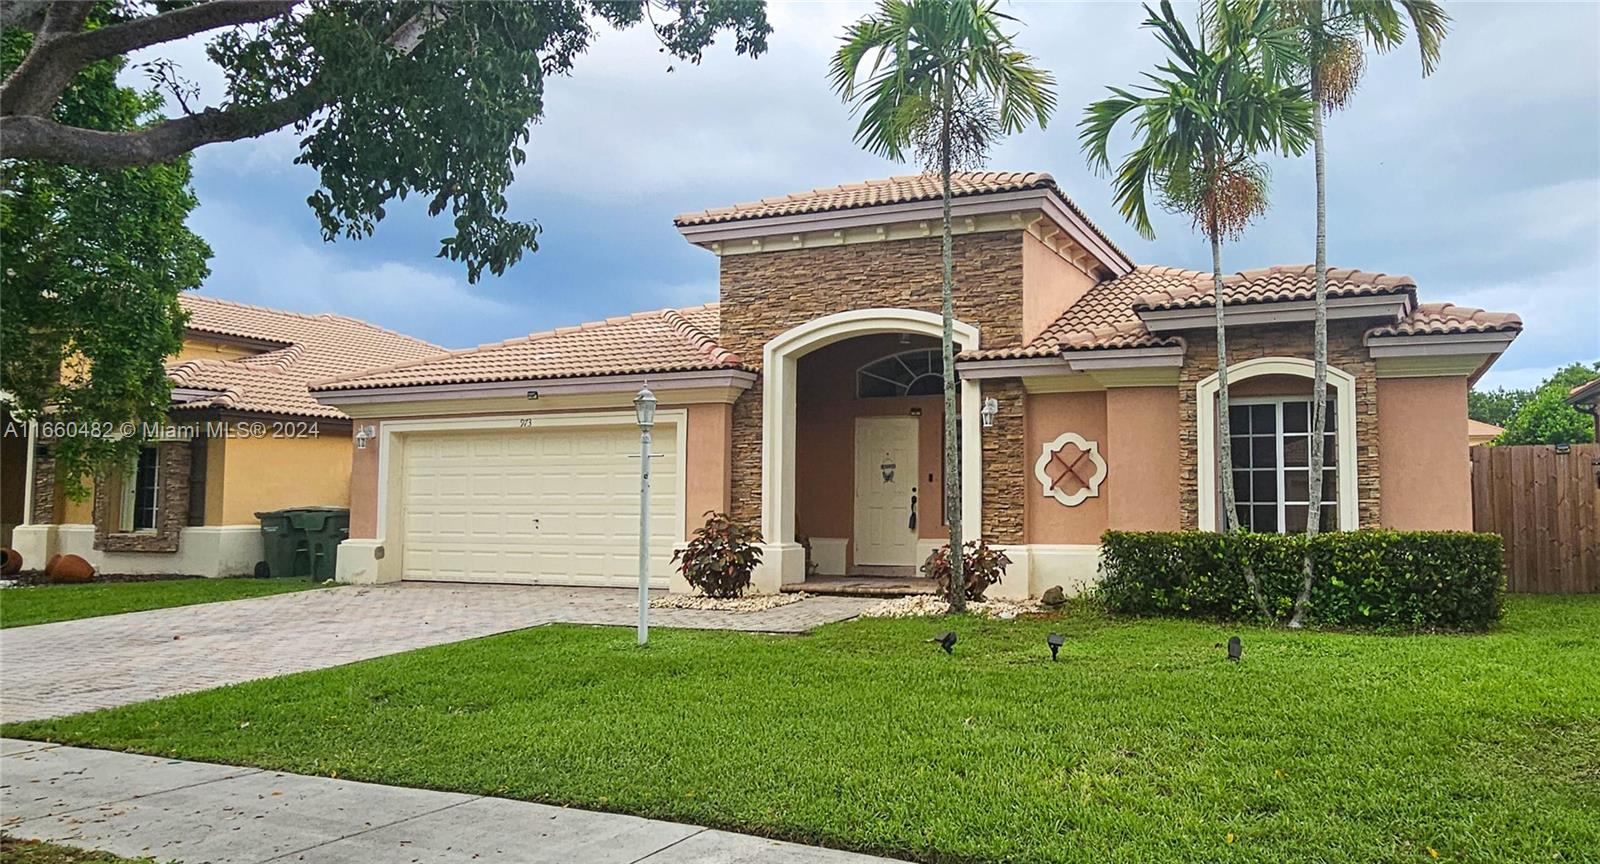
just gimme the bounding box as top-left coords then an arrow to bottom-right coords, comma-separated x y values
216,424 -> 350,525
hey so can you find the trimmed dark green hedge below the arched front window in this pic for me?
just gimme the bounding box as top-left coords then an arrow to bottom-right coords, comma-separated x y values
1098,531 -> 1506,630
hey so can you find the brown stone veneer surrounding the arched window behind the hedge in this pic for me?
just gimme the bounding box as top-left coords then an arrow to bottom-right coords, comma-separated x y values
1178,322 -> 1381,528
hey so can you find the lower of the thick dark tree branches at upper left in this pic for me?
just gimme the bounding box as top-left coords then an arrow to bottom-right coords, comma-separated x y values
0,91 -> 323,168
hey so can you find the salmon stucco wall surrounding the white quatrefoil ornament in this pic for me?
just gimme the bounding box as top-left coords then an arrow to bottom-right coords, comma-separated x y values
1030,390 -> 1112,544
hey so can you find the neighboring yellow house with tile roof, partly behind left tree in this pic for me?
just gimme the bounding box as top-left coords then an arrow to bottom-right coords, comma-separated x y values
9,294 -> 443,576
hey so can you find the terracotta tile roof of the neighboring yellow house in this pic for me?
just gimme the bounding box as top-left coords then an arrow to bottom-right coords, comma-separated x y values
166,294 -> 445,418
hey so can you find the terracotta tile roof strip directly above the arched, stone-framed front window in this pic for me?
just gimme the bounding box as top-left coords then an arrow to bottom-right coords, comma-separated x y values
1123,264 -> 1416,310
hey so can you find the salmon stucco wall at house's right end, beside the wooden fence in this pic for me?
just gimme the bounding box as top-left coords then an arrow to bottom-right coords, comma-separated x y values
1378,376 -> 1472,531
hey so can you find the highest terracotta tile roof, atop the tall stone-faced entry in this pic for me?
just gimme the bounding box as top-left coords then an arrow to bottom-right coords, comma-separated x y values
672,171 -> 1133,261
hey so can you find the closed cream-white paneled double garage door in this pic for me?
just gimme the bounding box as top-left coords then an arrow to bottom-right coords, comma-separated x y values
402,424 -> 680,586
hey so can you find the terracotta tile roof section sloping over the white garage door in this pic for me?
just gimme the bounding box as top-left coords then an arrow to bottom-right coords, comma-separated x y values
312,304 -> 744,392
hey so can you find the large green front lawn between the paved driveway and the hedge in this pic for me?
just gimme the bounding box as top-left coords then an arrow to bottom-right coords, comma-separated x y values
3,597 -> 1600,862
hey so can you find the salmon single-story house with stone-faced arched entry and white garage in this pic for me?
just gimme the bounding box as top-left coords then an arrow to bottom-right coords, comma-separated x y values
312,171 -> 1522,595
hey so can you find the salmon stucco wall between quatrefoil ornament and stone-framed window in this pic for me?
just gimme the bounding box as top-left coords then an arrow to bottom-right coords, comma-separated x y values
1101,387 -> 1182,531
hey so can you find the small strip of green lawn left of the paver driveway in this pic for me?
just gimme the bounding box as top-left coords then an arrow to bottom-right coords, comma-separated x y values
0,579 -> 315,627
